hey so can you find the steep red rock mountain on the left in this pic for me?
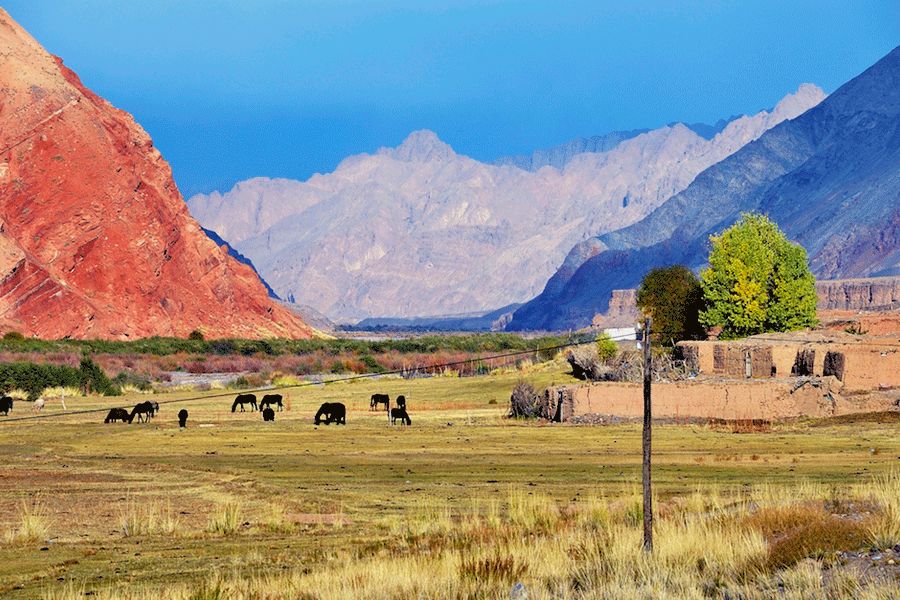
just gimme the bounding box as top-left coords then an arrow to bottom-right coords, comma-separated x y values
0,9 -> 314,339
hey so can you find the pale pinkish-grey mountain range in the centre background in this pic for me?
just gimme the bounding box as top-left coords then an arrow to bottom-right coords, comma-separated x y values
188,85 -> 824,321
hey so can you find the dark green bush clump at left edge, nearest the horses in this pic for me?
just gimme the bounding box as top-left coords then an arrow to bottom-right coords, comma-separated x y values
0,357 -> 122,400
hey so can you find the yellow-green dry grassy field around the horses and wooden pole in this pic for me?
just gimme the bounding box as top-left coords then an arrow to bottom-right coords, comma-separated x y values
0,363 -> 900,599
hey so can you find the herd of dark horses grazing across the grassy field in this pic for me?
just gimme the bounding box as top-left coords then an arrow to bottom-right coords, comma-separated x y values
89,394 -> 412,427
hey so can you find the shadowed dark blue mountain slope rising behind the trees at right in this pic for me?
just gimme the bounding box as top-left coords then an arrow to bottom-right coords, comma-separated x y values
509,49 -> 900,330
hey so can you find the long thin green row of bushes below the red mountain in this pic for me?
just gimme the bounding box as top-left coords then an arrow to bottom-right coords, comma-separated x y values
0,332 -> 565,356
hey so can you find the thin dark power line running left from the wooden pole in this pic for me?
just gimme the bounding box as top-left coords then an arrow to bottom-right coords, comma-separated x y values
0,334 -> 636,424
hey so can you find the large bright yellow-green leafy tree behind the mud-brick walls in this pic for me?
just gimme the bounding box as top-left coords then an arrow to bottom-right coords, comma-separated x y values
700,213 -> 818,339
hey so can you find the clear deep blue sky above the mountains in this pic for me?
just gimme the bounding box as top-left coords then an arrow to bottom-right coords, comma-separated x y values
2,0 -> 900,195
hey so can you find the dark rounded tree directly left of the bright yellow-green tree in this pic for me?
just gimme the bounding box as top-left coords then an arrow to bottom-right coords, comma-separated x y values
637,265 -> 706,344
